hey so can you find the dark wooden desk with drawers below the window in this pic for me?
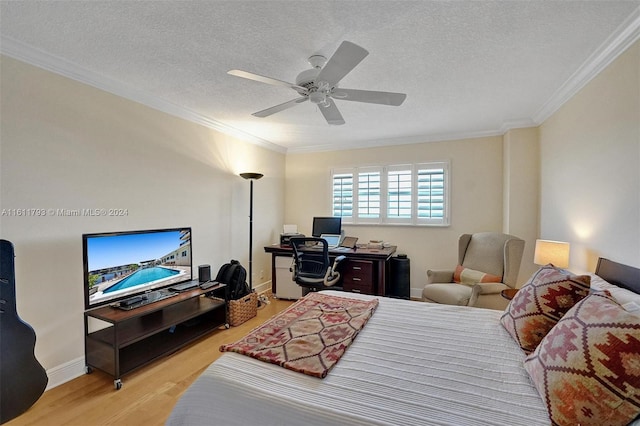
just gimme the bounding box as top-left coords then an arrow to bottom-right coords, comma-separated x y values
264,244 -> 396,296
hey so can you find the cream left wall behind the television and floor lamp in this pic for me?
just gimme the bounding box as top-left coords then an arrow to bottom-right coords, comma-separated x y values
0,57 -> 285,385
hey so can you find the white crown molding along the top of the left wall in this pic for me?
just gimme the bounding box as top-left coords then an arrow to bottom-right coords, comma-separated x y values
0,37 -> 286,153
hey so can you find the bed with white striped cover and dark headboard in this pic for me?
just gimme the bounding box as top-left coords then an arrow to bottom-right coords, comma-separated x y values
167,259 -> 640,426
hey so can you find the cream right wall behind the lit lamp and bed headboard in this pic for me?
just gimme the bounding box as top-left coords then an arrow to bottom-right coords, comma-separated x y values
540,42 -> 640,272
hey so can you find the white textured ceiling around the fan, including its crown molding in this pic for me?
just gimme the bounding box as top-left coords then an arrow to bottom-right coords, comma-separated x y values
0,0 -> 640,152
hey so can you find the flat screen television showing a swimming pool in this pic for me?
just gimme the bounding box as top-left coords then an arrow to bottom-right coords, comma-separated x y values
82,227 -> 193,309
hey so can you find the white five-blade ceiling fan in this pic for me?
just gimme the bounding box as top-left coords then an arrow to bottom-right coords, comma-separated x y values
227,41 -> 407,125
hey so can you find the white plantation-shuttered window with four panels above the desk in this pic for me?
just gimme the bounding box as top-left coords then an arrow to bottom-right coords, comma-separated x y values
331,162 -> 449,226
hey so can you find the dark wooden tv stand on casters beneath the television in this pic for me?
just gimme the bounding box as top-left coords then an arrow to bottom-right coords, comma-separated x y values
84,284 -> 229,389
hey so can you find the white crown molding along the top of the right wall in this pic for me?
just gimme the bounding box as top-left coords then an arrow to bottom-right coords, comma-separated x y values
533,6 -> 640,125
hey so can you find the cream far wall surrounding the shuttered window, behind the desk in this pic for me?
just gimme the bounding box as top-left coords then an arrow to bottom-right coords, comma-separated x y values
285,137 -> 520,297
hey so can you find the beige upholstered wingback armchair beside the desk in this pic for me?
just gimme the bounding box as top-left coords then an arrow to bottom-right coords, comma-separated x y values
422,232 -> 524,309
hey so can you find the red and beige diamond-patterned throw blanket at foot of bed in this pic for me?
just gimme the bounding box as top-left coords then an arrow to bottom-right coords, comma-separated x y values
220,293 -> 378,378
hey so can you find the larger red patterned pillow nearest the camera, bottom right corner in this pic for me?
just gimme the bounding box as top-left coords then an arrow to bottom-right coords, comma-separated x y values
524,293 -> 640,426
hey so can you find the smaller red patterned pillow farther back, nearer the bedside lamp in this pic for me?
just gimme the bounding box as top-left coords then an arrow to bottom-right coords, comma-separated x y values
500,264 -> 591,354
